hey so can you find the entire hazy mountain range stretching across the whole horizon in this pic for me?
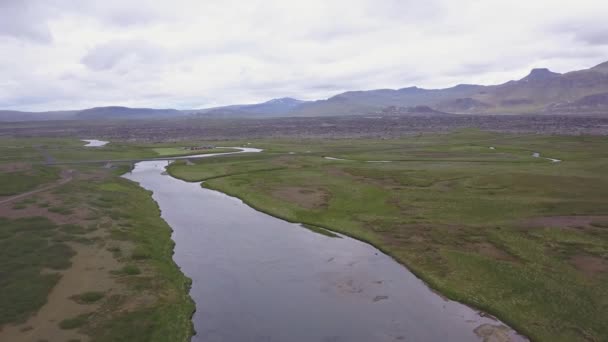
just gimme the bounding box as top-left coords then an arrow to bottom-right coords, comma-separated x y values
0,62 -> 608,121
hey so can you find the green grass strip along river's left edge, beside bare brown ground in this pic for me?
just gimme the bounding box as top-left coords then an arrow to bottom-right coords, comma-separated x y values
64,167 -> 194,341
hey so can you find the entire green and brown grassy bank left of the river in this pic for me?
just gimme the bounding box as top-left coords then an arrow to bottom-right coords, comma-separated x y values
0,139 -> 194,341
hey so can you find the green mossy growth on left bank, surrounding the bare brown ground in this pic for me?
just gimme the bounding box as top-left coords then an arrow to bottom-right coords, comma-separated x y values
0,138 -> 194,341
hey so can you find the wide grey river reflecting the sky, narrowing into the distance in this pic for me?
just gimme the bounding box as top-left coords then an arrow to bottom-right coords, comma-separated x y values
124,150 -> 525,342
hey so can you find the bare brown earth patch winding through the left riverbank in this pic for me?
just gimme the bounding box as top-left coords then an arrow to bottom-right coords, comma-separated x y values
0,170 -> 166,341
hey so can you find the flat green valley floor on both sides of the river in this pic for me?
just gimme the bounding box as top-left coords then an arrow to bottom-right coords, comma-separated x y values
0,130 -> 608,341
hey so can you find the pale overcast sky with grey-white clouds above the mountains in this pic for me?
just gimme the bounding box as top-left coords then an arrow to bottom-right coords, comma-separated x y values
0,0 -> 608,110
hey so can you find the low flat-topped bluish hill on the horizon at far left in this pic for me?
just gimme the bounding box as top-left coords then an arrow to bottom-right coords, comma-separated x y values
75,106 -> 184,120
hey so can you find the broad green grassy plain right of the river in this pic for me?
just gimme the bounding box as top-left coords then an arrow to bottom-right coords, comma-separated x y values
169,131 -> 608,341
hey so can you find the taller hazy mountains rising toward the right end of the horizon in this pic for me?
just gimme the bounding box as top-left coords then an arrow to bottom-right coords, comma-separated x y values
280,62 -> 608,116
